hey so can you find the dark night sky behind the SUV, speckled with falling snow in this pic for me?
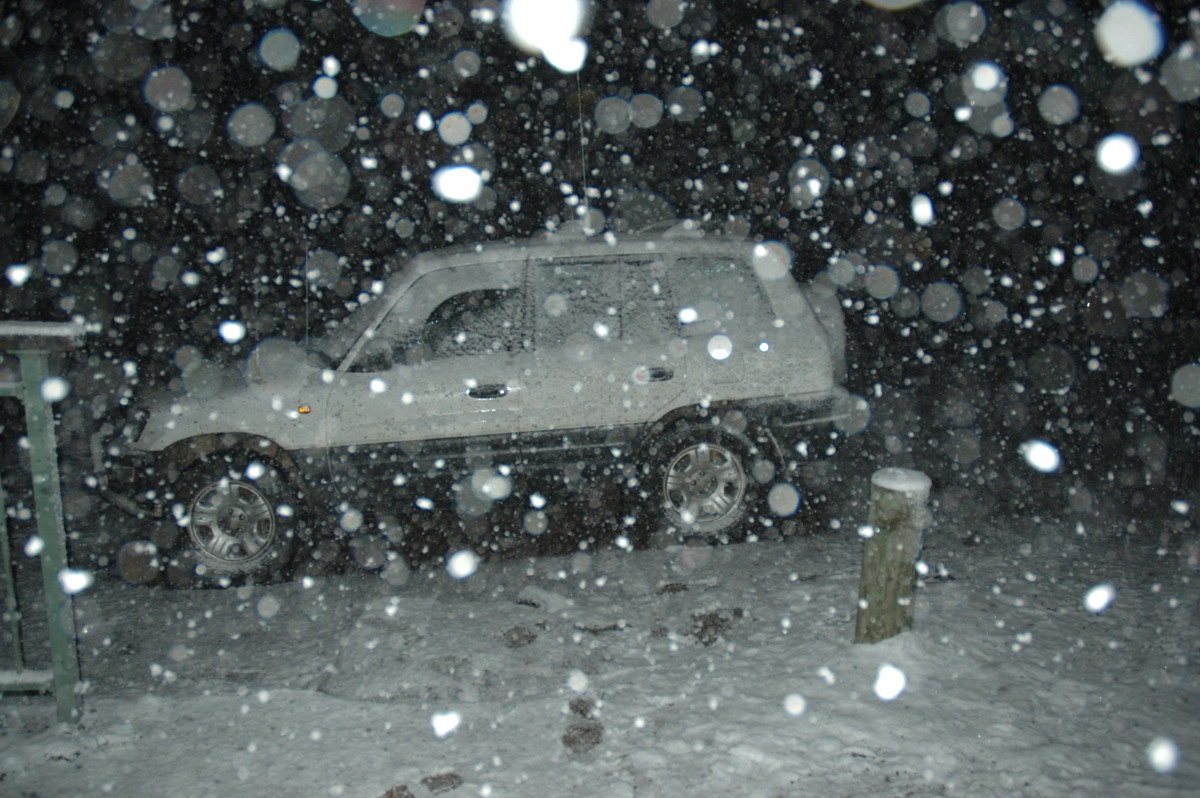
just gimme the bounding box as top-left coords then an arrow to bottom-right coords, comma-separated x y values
0,0 -> 1200,520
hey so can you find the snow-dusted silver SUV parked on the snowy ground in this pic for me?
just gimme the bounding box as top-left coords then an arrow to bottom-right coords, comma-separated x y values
94,228 -> 845,578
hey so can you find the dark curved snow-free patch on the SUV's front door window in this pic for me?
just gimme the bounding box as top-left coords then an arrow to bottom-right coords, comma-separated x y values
420,288 -> 524,358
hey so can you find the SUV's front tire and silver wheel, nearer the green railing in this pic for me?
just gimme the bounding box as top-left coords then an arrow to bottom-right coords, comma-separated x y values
173,451 -> 302,584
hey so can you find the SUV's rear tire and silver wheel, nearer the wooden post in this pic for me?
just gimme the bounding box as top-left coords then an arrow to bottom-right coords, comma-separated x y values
642,420 -> 774,540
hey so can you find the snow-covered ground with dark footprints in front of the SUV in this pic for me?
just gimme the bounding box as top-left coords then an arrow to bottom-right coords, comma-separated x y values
0,506 -> 1200,798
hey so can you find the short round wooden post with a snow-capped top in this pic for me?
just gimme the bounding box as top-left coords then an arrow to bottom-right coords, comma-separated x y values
854,468 -> 931,643
